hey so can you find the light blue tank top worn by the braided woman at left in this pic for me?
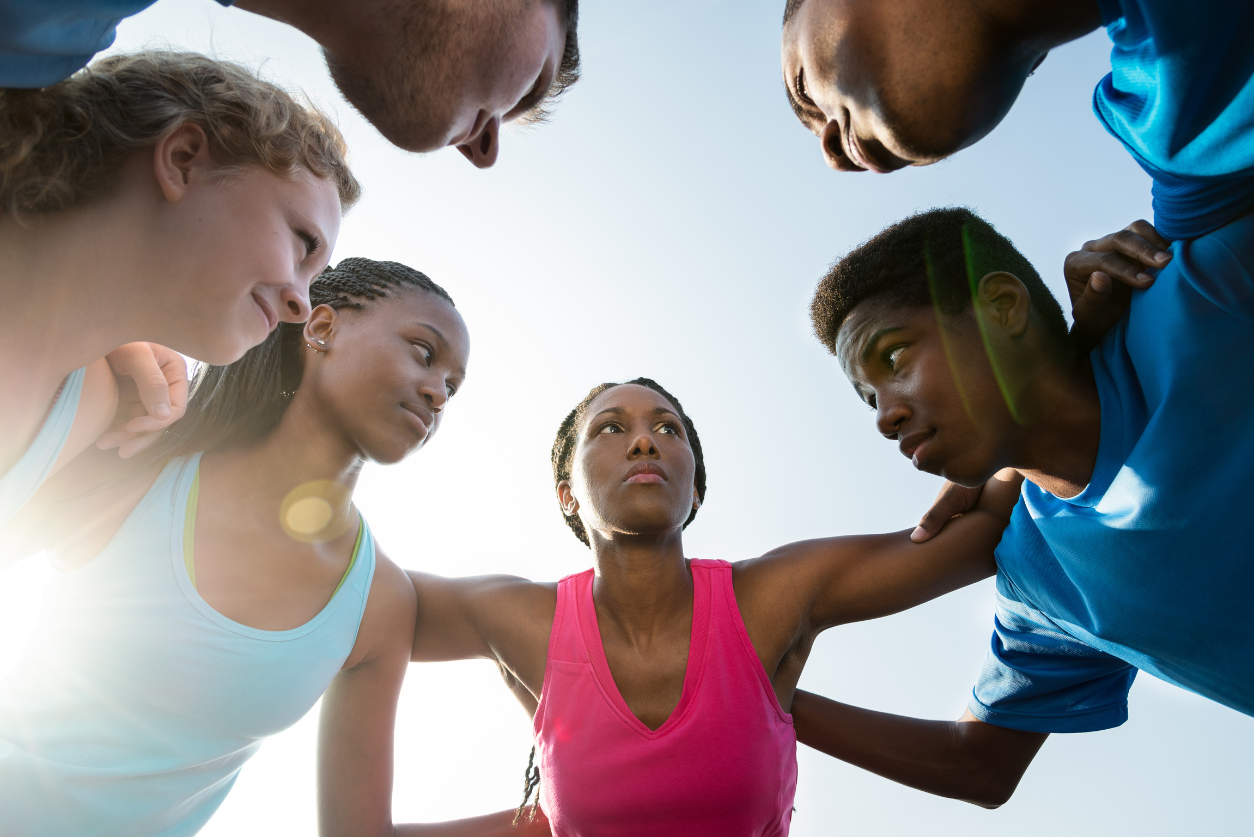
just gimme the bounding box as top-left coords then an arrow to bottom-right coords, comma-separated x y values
0,454 -> 375,837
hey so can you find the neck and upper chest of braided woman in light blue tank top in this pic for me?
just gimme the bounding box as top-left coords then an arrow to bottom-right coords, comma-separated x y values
211,393 -> 364,530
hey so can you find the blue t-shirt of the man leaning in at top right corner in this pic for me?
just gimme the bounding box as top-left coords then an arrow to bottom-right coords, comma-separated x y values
1093,0 -> 1254,238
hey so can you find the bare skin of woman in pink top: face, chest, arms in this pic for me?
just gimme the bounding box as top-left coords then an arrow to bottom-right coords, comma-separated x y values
410,384 -> 1018,833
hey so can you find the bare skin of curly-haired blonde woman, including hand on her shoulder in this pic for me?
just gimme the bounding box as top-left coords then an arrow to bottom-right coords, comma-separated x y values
0,124 -> 341,501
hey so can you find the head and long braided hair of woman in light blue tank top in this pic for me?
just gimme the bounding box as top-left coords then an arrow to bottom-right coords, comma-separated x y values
150,259 -> 470,463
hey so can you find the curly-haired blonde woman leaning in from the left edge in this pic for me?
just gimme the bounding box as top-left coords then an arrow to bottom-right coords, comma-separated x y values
0,51 -> 360,525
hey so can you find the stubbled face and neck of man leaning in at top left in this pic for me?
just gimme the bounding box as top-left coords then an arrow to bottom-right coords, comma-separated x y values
236,0 -> 566,168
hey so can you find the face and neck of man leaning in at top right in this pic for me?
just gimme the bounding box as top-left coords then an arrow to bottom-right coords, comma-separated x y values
781,0 -> 1101,173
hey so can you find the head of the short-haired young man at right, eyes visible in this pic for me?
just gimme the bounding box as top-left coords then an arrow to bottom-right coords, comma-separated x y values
810,207 -> 1075,486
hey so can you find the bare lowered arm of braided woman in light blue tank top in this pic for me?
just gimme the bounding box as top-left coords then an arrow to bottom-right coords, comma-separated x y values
317,558 -> 549,837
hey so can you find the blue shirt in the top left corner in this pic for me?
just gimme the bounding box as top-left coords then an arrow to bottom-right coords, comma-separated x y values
0,0 -> 234,88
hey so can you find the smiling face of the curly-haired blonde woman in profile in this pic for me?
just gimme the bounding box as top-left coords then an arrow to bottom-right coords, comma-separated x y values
162,167 -> 340,364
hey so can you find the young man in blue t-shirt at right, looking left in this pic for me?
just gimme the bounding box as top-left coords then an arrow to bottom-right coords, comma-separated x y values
793,208 -> 1254,806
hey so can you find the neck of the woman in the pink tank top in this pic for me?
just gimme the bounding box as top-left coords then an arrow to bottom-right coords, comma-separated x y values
592,528 -> 692,640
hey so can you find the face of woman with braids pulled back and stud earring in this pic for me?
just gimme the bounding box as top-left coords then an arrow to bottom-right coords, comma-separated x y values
297,289 -> 470,463
